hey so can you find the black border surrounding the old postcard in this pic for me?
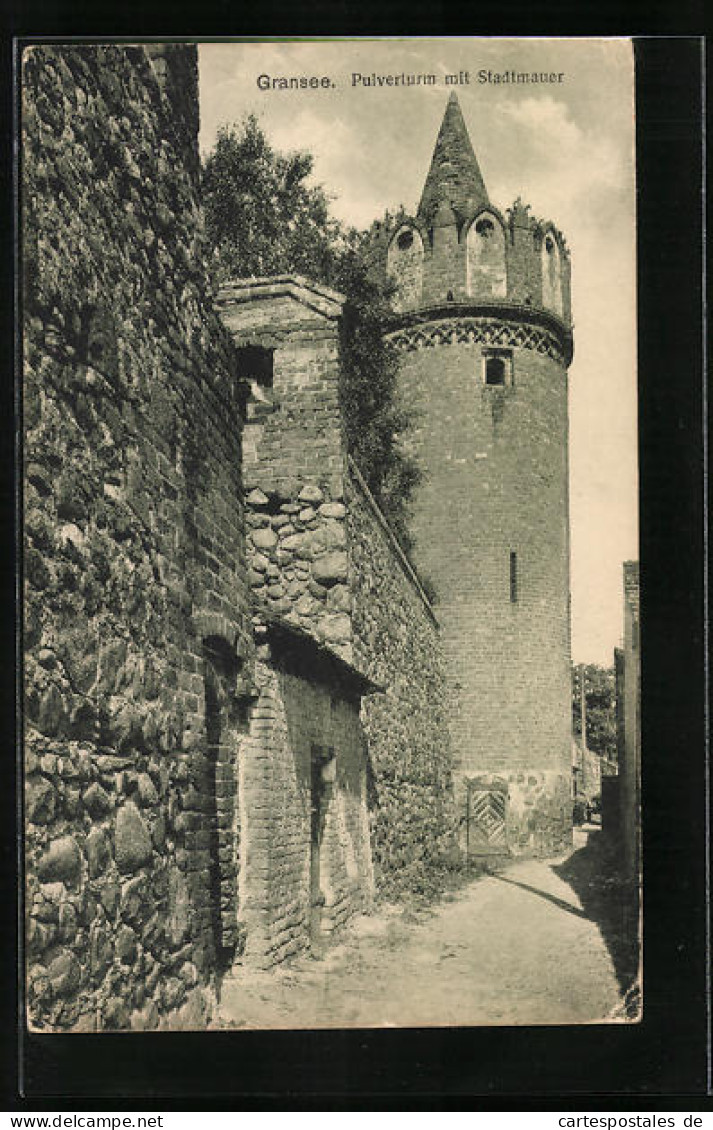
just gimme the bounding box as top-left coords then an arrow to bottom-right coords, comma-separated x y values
0,33 -> 711,1111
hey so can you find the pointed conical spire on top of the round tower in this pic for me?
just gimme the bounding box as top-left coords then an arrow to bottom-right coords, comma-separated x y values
418,92 -> 489,224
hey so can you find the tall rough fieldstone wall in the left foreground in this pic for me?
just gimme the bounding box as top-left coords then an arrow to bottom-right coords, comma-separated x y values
23,45 -> 252,1029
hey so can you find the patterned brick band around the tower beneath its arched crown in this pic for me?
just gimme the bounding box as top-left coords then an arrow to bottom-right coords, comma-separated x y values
386,318 -> 565,365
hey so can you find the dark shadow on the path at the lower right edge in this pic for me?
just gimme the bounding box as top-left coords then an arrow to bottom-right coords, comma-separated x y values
553,832 -> 638,993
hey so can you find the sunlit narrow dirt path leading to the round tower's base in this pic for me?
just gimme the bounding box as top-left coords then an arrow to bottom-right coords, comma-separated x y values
221,832 -> 620,1028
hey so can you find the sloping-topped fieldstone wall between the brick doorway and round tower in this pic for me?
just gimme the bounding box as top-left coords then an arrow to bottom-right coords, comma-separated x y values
347,470 -> 454,895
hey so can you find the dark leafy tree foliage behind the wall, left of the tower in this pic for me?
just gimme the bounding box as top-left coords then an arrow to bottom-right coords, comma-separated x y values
203,115 -> 420,550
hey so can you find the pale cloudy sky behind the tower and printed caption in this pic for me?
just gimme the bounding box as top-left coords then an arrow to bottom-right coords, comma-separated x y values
199,38 -> 638,666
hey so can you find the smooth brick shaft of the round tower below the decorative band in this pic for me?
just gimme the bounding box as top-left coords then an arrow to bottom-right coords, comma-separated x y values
393,323 -> 571,850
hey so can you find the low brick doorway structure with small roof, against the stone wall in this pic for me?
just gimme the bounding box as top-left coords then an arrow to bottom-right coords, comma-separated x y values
240,645 -> 373,967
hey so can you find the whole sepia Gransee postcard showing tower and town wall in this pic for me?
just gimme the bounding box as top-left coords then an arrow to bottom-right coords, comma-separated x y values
19,37 -> 645,1043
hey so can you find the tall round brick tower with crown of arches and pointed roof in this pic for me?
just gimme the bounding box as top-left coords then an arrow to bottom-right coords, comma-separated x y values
385,94 -> 572,854
